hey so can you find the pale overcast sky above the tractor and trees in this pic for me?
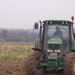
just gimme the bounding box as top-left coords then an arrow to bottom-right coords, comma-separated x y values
0,0 -> 75,29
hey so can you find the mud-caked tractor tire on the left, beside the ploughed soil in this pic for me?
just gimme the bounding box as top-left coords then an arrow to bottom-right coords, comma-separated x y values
25,51 -> 45,75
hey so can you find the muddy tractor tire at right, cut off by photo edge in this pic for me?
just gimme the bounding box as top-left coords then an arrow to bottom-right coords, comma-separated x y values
63,52 -> 75,75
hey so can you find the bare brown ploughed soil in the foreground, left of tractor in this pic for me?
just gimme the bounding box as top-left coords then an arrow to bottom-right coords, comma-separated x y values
0,60 -> 57,75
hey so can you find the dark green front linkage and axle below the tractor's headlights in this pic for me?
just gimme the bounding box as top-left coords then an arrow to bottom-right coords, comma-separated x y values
38,56 -> 63,68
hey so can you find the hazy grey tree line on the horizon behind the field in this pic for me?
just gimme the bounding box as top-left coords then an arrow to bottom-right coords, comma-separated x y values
0,29 -> 38,42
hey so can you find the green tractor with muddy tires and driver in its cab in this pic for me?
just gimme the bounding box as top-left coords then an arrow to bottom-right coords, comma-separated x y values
25,16 -> 75,75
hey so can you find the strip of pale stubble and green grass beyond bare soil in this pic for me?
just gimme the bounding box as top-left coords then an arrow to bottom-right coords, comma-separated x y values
0,42 -> 34,59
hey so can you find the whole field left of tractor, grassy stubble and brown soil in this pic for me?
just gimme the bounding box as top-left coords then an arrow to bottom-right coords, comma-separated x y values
0,42 -> 54,75
